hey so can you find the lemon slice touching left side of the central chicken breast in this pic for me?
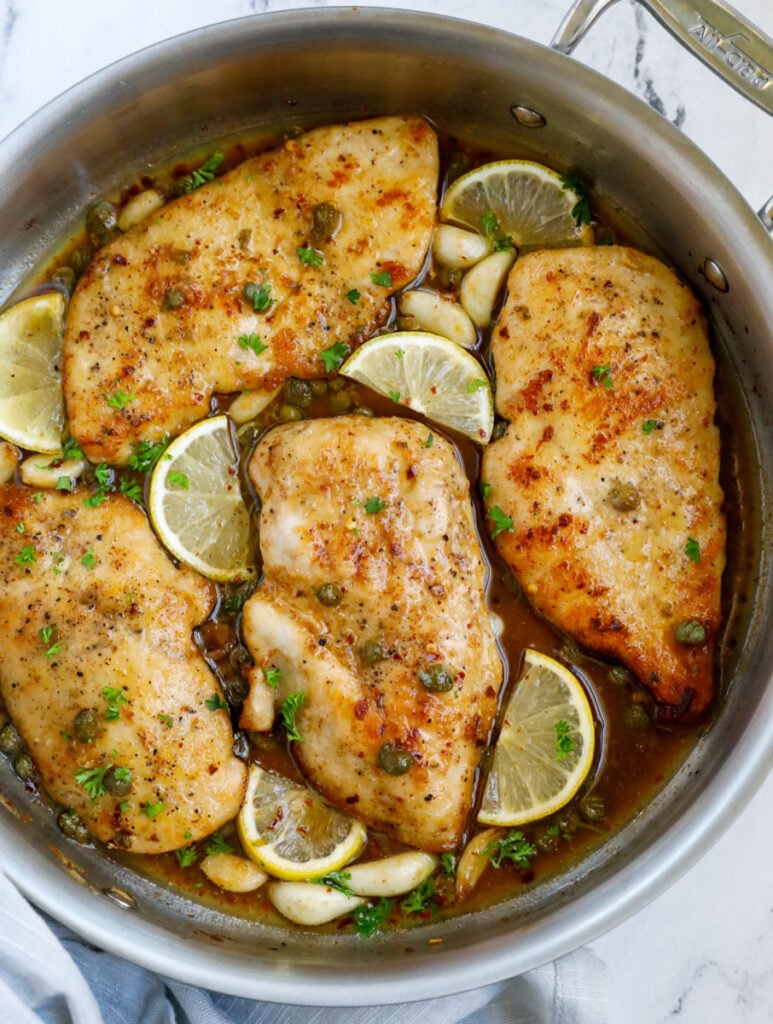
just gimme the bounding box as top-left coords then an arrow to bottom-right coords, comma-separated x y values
147,416 -> 255,583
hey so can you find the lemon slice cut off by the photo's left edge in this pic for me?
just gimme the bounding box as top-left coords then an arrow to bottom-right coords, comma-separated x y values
0,292 -> 65,455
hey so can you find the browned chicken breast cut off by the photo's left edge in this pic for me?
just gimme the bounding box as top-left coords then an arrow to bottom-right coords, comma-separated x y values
0,485 -> 247,853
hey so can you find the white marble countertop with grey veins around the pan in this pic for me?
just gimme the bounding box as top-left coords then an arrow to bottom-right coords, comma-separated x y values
0,0 -> 773,1024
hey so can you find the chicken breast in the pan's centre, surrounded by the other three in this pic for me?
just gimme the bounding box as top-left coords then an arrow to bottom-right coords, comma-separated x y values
244,416 -> 503,851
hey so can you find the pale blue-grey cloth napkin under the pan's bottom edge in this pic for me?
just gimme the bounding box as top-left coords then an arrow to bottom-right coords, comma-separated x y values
0,872 -> 607,1024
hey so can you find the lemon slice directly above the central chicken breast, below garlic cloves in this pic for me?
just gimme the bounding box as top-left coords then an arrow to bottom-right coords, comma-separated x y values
340,331 -> 493,444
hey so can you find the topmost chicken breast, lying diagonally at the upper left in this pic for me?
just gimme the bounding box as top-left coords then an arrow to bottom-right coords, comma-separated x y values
63,117 -> 438,465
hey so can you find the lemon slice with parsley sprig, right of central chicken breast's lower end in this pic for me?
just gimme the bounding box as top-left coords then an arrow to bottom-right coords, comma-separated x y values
478,649 -> 596,826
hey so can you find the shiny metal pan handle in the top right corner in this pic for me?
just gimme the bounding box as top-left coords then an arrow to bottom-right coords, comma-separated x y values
551,0 -> 773,115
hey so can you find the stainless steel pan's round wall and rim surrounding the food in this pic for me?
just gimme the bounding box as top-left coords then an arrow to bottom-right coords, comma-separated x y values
0,3 -> 773,1005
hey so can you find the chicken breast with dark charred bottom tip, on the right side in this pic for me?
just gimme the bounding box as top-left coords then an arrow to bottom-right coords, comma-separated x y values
482,246 -> 725,716
